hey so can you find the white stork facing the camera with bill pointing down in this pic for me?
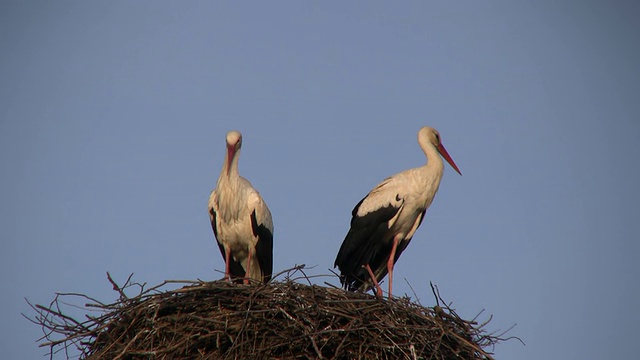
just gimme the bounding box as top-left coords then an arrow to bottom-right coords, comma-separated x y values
208,131 -> 273,284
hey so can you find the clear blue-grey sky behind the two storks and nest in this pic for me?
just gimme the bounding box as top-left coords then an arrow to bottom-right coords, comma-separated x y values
0,0 -> 640,359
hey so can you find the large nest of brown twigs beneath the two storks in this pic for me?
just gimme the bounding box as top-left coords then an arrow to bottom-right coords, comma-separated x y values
30,266 -> 505,359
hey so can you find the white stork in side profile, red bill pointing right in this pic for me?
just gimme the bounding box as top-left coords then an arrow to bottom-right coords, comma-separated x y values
333,126 -> 462,298
